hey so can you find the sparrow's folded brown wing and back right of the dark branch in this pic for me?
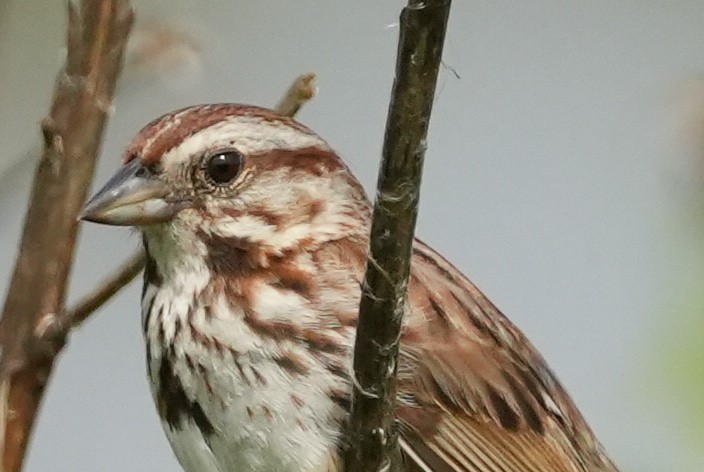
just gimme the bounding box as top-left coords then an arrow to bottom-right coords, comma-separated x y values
398,242 -> 617,472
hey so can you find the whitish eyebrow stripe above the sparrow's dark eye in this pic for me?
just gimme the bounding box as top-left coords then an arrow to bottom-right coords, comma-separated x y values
162,115 -> 330,168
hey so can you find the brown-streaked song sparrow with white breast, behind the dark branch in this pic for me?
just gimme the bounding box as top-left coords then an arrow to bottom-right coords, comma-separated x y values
83,104 -> 616,472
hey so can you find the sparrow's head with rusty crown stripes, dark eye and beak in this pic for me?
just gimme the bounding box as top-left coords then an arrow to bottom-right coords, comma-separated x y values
82,104 -> 369,276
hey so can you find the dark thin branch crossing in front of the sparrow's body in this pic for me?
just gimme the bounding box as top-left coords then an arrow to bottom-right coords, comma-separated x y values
344,0 -> 450,472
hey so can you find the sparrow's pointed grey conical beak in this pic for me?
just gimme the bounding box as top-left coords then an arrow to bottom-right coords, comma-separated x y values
80,159 -> 183,226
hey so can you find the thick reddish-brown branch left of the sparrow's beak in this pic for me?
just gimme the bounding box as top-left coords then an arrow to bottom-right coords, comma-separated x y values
0,0 -> 133,472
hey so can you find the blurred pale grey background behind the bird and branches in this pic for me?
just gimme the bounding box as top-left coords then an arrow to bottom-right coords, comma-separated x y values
0,0 -> 704,472
